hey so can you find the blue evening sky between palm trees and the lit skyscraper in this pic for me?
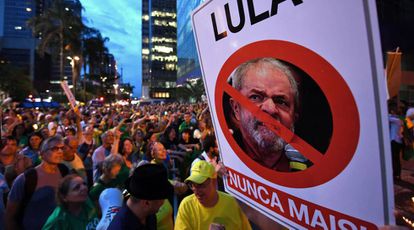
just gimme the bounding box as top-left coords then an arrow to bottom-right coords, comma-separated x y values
81,0 -> 142,97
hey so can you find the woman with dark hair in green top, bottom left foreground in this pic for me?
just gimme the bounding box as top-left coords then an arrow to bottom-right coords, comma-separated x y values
42,174 -> 99,230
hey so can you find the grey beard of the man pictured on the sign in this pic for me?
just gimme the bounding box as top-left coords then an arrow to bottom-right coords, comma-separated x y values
242,114 -> 293,157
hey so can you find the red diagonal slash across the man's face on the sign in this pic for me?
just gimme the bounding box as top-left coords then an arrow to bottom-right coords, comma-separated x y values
223,84 -> 323,164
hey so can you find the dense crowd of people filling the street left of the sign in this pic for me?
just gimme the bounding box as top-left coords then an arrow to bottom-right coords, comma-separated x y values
0,103 -> 250,229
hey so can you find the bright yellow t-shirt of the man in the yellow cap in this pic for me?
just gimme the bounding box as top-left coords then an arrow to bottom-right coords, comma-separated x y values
174,191 -> 252,230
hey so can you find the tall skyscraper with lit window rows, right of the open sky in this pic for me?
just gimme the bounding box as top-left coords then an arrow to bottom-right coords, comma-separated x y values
142,0 -> 177,99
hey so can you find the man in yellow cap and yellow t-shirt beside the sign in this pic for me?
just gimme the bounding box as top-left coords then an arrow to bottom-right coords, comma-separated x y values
175,160 -> 251,230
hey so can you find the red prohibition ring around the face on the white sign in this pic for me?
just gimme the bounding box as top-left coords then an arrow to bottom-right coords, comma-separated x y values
214,40 -> 360,188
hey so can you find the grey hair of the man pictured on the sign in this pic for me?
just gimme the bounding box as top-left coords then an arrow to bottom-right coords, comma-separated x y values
231,57 -> 299,111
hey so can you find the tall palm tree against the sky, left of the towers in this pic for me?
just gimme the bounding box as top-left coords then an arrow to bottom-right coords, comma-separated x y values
27,0 -> 84,93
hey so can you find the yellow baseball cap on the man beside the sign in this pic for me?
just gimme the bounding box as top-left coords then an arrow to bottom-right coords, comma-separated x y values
185,160 -> 217,184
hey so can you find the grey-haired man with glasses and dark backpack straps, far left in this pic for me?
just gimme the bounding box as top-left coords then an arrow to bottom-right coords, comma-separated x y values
6,135 -> 68,229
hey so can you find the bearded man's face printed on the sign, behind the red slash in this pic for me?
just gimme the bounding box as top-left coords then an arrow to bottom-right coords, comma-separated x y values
231,62 -> 295,167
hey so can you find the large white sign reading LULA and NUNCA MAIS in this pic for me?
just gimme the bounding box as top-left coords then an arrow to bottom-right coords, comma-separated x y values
192,0 -> 394,229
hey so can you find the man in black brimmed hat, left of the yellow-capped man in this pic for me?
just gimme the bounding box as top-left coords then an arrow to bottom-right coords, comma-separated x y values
108,164 -> 173,229
